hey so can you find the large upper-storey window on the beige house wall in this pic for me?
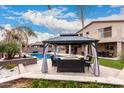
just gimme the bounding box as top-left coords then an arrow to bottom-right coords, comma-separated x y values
98,26 -> 112,38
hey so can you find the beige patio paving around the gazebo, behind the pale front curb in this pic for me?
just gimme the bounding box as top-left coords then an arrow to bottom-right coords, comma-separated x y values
25,59 -> 120,77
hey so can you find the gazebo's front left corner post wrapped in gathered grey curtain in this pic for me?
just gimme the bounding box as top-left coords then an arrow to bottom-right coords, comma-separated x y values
41,43 -> 48,73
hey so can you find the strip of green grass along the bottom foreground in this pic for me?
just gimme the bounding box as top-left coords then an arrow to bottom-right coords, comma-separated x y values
31,80 -> 124,88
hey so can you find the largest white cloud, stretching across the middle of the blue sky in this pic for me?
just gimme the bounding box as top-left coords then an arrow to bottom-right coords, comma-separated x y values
22,8 -> 81,33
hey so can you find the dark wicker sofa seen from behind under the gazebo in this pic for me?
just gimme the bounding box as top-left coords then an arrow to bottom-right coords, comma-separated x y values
57,58 -> 85,72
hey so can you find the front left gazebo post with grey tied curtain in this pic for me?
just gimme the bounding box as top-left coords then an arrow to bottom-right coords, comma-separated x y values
41,45 -> 48,73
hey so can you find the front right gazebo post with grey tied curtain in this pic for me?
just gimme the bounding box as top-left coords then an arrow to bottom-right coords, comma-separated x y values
91,43 -> 100,76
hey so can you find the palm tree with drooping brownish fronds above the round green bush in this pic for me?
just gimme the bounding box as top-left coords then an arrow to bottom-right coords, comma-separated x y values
0,26 -> 37,56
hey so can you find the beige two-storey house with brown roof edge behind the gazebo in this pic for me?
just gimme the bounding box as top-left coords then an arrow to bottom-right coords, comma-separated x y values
77,20 -> 124,57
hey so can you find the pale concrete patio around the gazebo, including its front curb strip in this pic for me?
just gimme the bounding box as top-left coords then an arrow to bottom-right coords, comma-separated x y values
0,59 -> 124,85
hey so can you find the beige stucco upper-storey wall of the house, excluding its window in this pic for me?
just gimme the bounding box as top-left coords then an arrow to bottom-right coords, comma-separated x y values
78,22 -> 124,42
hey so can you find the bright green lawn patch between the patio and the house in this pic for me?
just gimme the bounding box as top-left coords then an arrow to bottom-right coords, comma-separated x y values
99,58 -> 124,69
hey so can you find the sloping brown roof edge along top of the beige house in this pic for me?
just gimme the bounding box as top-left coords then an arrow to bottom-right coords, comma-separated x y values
76,20 -> 124,34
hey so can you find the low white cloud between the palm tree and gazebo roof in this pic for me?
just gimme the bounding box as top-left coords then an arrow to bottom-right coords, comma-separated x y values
29,31 -> 55,43
